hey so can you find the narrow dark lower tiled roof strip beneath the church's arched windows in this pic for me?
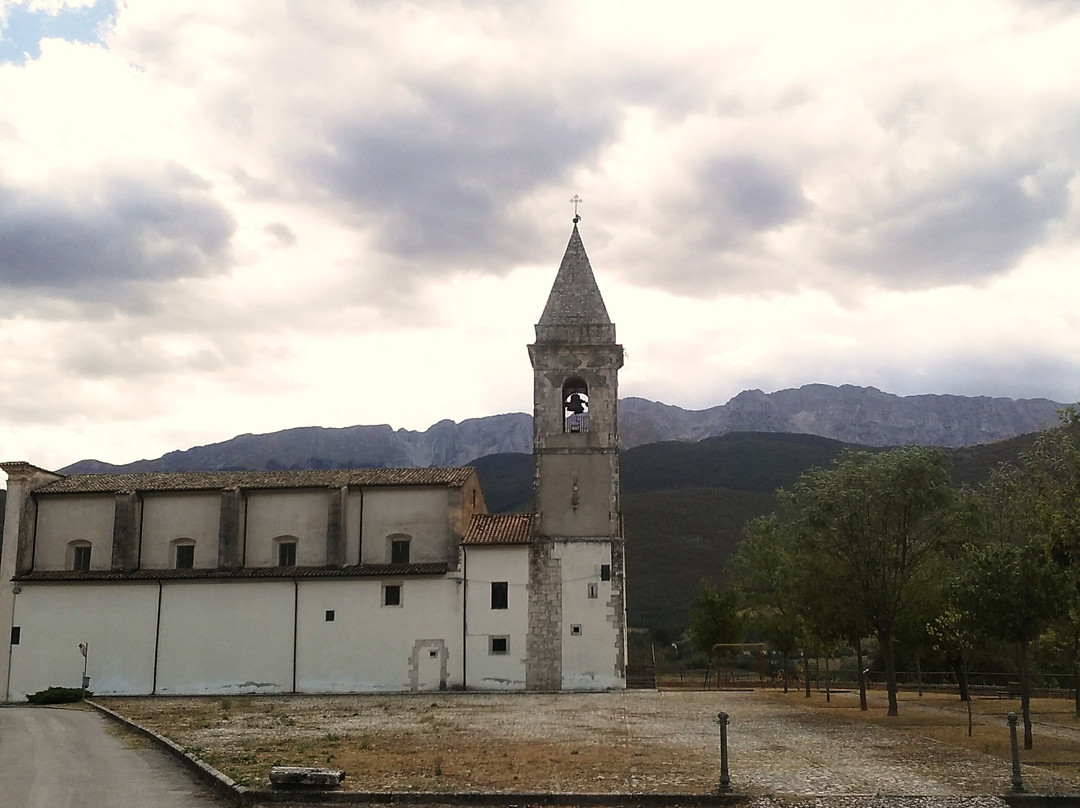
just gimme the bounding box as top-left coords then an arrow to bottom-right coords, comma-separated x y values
12,562 -> 449,582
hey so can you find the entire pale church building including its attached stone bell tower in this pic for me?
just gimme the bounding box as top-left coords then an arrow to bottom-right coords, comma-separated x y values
0,217 -> 626,701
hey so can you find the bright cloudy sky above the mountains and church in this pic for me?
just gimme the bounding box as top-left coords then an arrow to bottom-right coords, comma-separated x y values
0,0 -> 1080,468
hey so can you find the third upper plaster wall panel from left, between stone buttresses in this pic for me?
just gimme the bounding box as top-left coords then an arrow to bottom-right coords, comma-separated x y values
244,489 -> 329,567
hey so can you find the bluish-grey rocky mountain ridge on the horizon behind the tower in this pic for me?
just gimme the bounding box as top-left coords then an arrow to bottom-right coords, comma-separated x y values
62,385 -> 1064,473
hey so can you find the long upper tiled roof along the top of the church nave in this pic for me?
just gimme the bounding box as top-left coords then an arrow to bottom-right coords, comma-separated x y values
36,466 -> 475,494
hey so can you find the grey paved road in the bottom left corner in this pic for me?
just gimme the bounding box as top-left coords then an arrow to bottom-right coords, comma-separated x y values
0,706 -> 226,808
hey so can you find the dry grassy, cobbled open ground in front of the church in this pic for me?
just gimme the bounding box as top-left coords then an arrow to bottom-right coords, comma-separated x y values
98,690 -> 1080,795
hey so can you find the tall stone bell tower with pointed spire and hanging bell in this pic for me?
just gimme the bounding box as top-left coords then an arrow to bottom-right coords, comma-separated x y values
526,216 -> 626,690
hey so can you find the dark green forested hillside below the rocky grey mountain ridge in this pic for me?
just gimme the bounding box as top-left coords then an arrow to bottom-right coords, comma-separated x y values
472,432 -> 1034,636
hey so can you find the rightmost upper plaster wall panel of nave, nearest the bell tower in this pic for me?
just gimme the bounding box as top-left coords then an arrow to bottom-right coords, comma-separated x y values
363,486 -> 457,564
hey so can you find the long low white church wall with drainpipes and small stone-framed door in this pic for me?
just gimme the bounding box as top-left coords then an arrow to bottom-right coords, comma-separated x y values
9,577 -> 462,701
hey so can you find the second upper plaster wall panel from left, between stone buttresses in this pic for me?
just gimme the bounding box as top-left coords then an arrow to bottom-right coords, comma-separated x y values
139,491 -> 221,569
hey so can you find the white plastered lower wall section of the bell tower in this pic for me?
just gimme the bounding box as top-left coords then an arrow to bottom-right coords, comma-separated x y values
555,540 -> 625,690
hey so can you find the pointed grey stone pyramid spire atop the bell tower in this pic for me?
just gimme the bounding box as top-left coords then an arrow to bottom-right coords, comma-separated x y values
537,223 -> 615,344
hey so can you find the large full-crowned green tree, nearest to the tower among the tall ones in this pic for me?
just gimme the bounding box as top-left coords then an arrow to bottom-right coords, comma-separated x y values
779,447 -> 953,715
